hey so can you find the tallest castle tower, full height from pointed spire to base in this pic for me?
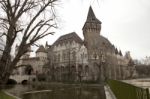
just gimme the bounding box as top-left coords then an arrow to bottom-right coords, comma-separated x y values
82,6 -> 104,80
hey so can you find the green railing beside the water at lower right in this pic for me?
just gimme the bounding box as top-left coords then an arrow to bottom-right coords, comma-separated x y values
107,80 -> 150,99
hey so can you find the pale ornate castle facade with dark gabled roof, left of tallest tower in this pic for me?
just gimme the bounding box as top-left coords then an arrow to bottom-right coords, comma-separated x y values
45,32 -> 89,81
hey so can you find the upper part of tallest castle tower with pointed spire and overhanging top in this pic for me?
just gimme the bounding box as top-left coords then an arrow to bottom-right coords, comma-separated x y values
82,6 -> 101,48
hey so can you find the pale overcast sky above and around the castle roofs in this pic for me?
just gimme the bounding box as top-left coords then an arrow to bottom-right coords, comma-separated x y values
36,0 -> 150,59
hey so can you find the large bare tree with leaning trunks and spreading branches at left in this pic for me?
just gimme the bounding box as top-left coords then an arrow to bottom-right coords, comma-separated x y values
0,0 -> 57,85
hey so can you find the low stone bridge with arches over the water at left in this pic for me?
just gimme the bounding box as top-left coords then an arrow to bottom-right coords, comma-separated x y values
10,75 -> 36,83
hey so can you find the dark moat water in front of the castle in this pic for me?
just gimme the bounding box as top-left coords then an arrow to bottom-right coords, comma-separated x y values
6,85 -> 106,99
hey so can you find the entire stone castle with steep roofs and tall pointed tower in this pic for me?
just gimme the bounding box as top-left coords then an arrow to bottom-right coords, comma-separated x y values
13,7 -> 133,81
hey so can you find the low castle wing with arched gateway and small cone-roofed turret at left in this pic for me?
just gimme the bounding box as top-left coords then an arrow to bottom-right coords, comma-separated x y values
13,45 -> 48,75
